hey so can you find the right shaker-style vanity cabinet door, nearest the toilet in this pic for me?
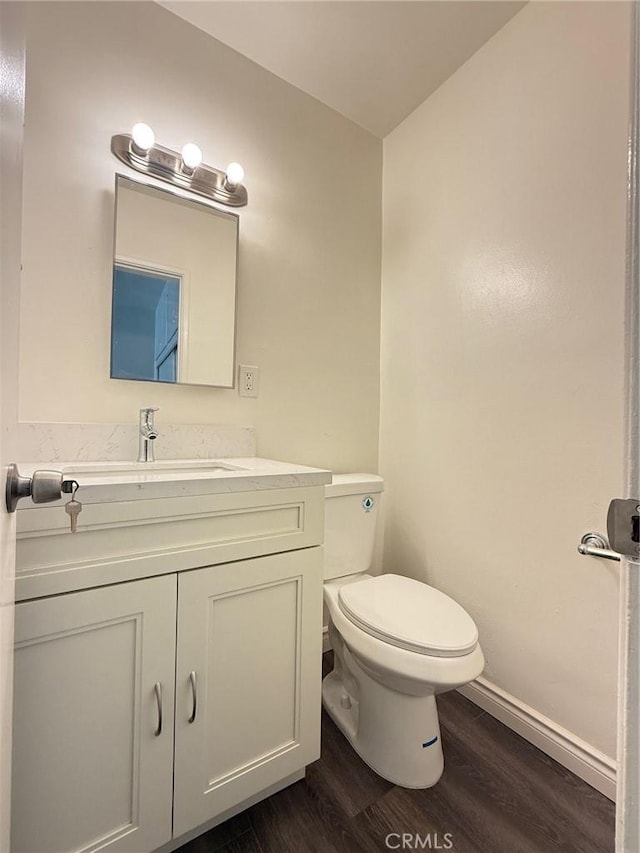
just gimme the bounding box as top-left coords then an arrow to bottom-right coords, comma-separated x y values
173,548 -> 322,837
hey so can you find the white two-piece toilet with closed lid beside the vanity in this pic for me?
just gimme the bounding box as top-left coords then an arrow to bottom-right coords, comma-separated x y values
322,474 -> 484,788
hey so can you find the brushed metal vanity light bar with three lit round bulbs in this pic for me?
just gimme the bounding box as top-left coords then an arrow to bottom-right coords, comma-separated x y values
111,122 -> 247,207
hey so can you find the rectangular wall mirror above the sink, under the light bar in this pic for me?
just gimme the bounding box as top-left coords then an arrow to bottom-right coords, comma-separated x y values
111,175 -> 238,388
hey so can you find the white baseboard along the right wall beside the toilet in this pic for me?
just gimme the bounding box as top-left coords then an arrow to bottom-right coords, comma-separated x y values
458,677 -> 616,801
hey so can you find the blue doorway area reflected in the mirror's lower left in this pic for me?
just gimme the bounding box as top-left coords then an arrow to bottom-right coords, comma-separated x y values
111,264 -> 180,382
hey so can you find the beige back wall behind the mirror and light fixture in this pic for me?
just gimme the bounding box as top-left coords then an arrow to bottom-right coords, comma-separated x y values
19,2 -> 382,471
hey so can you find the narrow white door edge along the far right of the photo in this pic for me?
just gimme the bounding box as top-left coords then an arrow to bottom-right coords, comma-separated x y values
616,3 -> 640,853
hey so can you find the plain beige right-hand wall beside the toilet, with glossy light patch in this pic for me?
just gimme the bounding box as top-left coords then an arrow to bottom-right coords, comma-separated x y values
381,3 -> 630,756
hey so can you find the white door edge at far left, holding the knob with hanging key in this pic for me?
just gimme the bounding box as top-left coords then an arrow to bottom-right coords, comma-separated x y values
0,3 -> 25,850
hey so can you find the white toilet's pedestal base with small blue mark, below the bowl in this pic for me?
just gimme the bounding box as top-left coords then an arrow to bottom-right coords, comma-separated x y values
322,632 -> 444,788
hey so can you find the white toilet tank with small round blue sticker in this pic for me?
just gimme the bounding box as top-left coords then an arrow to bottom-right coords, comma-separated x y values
324,474 -> 384,580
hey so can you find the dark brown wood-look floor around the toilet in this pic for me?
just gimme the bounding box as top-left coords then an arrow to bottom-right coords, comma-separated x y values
178,655 -> 615,853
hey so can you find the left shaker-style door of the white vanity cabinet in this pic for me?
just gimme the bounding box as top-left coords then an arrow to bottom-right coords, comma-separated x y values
11,575 -> 176,853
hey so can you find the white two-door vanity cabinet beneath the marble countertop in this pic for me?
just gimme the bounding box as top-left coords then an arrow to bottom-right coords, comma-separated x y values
11,480 -> 324,853
